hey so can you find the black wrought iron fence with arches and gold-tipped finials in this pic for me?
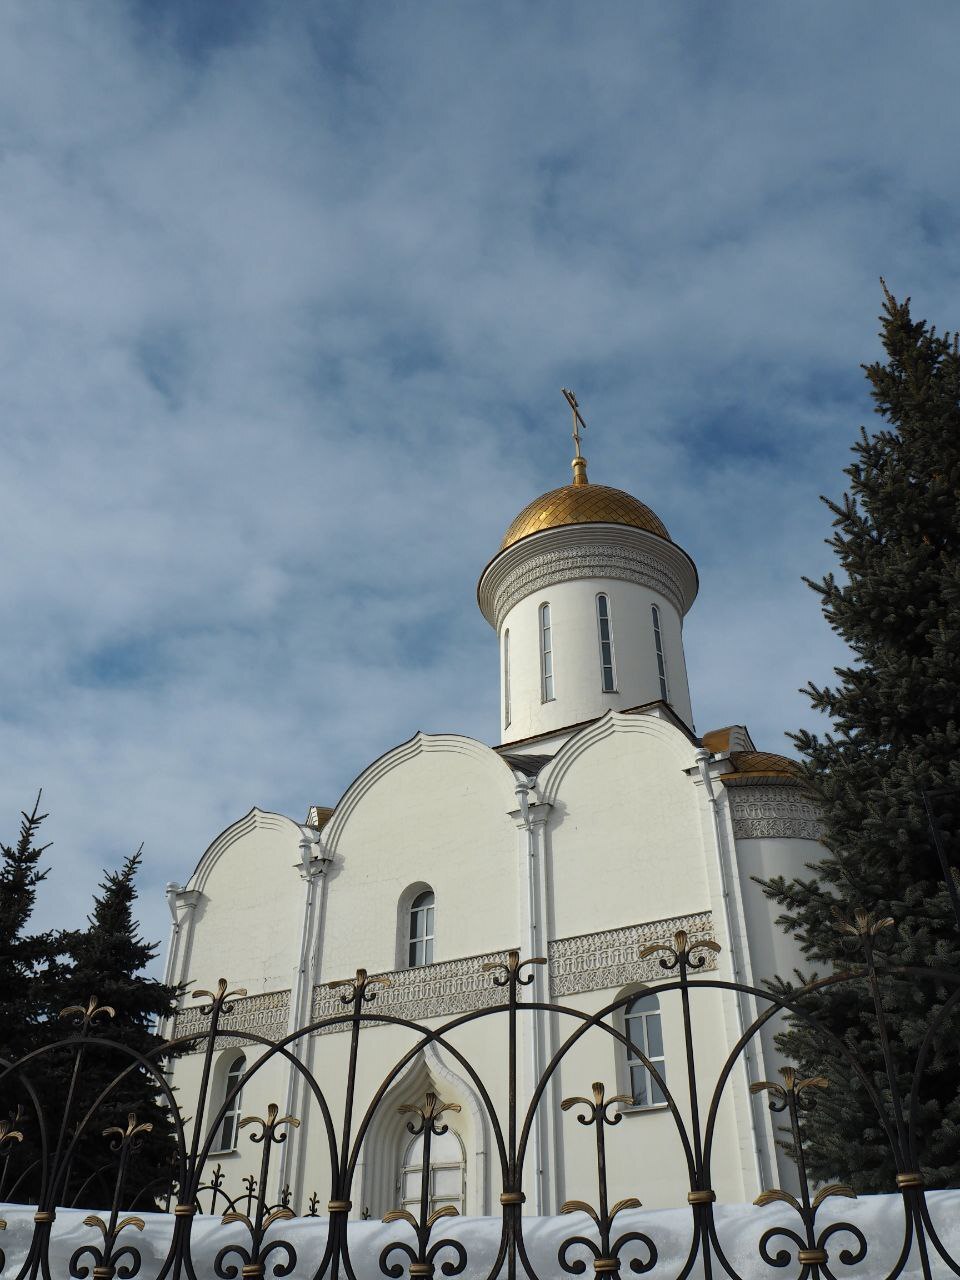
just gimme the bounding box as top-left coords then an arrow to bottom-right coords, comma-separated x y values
0,913 -> 960,1280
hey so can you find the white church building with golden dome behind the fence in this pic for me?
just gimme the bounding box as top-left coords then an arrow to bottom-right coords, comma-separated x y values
165,419 -> 822,1217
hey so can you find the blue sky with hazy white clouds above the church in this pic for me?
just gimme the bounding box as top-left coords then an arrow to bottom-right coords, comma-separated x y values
0,0 -> 960,957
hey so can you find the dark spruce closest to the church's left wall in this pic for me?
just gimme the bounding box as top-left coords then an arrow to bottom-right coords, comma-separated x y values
56,850 -> 177,1208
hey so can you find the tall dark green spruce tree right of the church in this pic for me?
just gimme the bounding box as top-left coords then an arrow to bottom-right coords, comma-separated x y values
765,285 -> 960,1190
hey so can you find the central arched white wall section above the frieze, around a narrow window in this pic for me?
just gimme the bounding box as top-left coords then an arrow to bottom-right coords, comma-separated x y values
313,733 -> 520,973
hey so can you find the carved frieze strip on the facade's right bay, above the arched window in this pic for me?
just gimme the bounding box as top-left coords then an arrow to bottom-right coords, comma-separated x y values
549,911 -> 717,998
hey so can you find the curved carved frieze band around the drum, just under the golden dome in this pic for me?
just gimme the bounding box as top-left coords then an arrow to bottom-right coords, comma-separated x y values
494,543 -> 684,627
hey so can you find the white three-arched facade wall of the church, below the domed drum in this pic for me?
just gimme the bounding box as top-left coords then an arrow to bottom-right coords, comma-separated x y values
163,713 -> 819,1216
